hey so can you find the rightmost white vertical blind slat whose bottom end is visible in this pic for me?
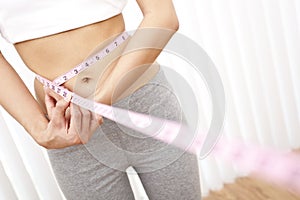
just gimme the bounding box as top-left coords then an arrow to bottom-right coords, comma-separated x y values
262,0 -> 300,146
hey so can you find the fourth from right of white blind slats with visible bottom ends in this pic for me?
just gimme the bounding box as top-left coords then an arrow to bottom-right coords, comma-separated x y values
211,1 -> 257,143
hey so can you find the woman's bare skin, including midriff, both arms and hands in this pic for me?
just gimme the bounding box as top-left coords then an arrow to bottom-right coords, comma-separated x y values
0,0 -> 178,149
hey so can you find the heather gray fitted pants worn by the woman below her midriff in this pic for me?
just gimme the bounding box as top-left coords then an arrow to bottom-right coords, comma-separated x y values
48,70 -> 201,200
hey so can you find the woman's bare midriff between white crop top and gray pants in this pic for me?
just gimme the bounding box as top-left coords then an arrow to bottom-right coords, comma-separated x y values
14,14 -> 159,110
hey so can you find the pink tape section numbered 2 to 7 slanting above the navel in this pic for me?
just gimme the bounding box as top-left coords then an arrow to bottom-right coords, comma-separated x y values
53,32 -> 129,85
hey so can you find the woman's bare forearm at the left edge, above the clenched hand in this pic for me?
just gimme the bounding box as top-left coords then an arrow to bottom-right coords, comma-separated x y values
0,52 -> 48,139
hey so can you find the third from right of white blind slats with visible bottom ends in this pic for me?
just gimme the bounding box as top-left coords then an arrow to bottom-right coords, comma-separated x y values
230,0 -> 273,146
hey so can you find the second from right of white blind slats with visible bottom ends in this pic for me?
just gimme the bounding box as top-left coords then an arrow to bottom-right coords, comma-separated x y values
247,0 -> 289,149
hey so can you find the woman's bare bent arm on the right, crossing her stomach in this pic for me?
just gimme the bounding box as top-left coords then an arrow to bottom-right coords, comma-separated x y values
95,0 -> 179,104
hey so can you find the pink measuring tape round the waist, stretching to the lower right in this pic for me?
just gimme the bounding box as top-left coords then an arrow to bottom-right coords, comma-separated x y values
36,33 -> 300,195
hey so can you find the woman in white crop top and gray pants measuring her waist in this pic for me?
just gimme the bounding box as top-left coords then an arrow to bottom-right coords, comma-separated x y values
0,0 -> 200,199
